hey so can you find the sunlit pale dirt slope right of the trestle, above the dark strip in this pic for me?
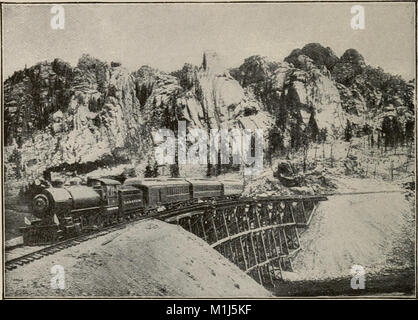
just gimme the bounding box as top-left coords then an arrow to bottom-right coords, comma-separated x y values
288,178 -> 415,281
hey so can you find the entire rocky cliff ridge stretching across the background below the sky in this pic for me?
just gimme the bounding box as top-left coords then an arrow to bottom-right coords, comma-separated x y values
4,44 -> 413,179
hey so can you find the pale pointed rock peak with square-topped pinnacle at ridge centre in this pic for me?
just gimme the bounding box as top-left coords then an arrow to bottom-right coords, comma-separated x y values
165,52 -> 271,129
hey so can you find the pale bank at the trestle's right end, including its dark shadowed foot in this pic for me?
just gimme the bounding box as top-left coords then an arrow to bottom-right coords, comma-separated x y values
276,177 -> 416,296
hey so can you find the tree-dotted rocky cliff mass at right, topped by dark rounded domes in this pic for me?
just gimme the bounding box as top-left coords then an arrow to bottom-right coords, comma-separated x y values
231,43 -> 414,149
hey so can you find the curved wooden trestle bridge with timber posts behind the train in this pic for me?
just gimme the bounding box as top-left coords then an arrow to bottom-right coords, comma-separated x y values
164,196 -> 327,286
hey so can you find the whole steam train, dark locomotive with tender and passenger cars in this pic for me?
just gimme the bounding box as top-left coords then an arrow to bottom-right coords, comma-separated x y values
21,178 -> 243,244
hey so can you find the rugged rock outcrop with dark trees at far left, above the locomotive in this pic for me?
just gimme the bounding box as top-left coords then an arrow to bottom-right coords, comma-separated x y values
5,55 -> 151,180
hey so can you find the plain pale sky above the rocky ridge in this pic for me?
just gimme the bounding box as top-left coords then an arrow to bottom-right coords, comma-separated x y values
3,3 -> 415,80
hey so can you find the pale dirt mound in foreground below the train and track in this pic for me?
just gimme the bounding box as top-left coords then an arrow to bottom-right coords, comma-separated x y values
6,220 -> 270,297
